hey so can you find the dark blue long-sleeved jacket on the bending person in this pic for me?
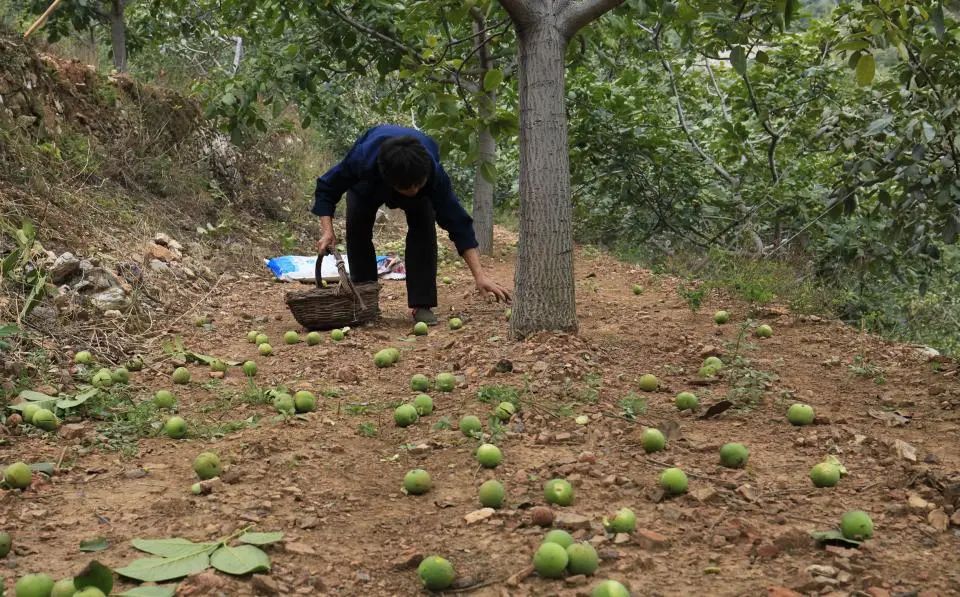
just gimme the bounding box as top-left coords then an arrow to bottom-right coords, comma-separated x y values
311,124 -> 479,255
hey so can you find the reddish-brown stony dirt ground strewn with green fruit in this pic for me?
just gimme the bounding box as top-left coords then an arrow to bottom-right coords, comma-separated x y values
0,230 -> 960,597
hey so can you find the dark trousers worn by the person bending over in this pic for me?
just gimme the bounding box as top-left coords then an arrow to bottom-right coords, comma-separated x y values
347,190 -> 437,308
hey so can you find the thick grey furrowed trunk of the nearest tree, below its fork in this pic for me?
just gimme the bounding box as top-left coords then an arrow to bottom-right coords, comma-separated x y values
510,21 -> 577,337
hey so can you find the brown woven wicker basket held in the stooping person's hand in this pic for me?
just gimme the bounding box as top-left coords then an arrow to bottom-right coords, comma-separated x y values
286,249 -> 380,330
